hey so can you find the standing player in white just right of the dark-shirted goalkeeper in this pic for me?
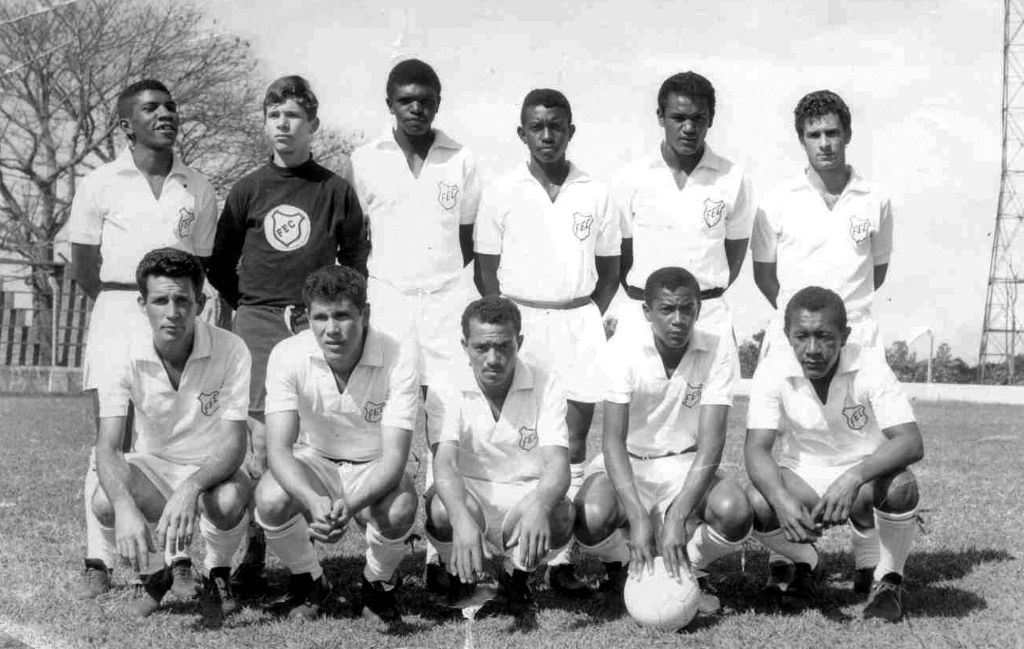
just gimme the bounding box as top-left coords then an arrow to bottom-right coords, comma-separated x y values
349,58 -> 480,590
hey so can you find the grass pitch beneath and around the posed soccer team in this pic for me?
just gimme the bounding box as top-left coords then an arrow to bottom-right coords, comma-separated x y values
0,396 -> 1024,649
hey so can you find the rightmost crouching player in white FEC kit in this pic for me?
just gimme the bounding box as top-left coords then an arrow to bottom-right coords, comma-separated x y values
745,287 -> 924,621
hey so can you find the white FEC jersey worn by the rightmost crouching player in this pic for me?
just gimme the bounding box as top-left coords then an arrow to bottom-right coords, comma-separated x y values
746,347 -> 914,467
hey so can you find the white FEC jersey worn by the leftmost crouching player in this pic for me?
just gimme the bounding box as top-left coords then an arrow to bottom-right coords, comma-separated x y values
96,321 -> 252,465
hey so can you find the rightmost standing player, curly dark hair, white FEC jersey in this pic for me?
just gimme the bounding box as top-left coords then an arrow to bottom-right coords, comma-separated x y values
751,90 -> 893,358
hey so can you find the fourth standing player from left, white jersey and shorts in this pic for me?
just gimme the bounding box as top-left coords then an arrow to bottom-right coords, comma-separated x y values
475,89 -> 621,597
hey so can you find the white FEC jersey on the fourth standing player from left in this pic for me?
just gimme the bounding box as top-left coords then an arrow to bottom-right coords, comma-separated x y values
474,165 -> 622,302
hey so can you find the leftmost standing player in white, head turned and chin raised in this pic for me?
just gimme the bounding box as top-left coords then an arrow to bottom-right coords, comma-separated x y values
68,79 -> 217,598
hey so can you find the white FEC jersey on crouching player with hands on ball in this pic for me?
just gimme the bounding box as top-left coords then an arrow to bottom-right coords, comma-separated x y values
605,326 -> 736,458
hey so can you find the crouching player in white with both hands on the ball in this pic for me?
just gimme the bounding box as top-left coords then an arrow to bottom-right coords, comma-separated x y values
575,267 -> 753,614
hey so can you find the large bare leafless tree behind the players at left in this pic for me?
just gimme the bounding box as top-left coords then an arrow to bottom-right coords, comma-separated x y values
0,0 -> 357,364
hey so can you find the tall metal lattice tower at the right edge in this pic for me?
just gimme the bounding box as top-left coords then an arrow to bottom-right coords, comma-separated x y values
978,0 -> 1024,383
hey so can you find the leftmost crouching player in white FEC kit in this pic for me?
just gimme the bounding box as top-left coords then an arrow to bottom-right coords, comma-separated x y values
86,248 -> 252,619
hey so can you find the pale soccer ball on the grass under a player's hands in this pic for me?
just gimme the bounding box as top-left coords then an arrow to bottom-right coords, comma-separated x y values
623,557 -> 700,631
